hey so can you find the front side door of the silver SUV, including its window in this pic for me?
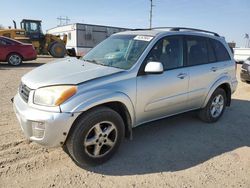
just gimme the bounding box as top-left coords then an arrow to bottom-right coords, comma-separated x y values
136,36 -> 189,125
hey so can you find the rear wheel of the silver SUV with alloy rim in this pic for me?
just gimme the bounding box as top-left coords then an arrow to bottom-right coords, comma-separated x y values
199,88 -> 227,123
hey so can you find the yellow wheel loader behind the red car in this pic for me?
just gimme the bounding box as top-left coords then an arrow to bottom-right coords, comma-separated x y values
0,19 -> 67,58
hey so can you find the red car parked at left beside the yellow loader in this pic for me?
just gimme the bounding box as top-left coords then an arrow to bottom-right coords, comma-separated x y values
0,36 -> 37,66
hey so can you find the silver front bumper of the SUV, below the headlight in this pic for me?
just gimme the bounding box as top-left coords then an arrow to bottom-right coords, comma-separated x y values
13,94 -> 77,147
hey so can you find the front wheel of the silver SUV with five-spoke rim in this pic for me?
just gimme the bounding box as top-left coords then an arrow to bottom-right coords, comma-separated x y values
66,107 -> 125,167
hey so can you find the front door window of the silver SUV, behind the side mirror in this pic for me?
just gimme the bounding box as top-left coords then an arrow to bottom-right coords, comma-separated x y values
146,37 -> 183,70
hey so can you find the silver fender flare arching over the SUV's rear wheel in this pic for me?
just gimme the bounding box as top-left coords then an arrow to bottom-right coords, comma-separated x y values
201,75 -> 232,108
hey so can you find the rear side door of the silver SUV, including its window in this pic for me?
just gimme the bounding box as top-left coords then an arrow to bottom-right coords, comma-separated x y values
185,36 -> 229,109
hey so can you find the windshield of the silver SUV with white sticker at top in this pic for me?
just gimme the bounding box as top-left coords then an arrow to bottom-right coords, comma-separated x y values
81,35 -> 153,70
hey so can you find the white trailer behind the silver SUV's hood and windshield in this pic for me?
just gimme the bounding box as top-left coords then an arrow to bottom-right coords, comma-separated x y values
47,23 -> 128,56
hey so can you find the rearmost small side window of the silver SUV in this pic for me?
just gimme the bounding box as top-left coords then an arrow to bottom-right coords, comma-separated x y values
210,39 -> 231,61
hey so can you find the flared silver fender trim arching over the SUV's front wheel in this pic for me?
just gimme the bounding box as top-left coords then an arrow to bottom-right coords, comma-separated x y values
61,89 -> 135,125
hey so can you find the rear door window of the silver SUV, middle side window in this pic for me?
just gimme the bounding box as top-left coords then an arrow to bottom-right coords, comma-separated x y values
186,36 -> 209,66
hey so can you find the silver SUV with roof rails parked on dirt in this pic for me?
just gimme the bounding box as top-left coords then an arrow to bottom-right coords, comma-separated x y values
13,28 -> 237,166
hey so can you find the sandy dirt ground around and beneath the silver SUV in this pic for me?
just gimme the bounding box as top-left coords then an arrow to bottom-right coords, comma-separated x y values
0,58 -> 250,188
